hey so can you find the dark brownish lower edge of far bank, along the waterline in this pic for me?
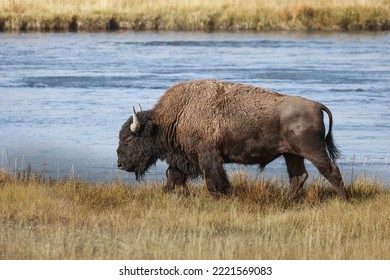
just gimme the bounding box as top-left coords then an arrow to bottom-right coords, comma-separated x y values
0,16 -> 390,33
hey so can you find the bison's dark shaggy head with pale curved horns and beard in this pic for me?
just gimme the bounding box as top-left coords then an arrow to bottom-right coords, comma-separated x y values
117,108 -> 159,180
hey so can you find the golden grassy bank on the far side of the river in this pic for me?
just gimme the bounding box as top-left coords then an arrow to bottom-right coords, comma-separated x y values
0,0 -> 390,31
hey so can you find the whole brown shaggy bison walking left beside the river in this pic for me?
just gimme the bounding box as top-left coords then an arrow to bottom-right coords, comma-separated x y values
117,80 -> 346,200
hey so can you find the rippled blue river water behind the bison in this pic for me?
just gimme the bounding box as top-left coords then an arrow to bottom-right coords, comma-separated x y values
0,33 -> 390,185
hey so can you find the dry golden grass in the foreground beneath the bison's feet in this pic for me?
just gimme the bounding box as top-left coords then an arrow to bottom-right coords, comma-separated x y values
0,167 -> 390,259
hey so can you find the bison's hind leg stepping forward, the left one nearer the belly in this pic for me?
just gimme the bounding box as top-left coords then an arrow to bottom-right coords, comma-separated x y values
283,154 -> 308,200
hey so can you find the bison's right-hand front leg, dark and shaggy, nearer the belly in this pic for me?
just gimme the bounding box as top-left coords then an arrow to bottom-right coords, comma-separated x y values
198,152 -> 230,194
